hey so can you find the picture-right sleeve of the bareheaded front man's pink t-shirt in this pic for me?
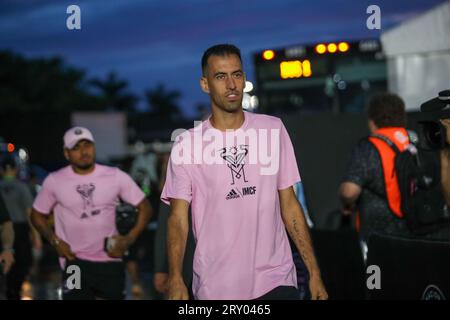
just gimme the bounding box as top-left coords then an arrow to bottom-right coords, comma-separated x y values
277,123 -> 301,190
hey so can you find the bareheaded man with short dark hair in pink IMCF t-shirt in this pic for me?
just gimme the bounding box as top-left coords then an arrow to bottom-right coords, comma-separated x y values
161,45 -> 328,300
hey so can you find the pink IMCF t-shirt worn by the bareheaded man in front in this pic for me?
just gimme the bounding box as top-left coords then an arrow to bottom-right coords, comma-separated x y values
161,112 -> 300,299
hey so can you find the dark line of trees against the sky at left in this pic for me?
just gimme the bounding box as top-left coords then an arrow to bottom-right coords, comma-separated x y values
0,51 -> 181,119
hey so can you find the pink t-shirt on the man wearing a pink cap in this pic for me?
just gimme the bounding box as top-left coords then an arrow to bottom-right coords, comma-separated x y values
33,164 -> 145,261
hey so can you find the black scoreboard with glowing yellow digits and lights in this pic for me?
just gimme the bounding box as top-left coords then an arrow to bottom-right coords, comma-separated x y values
253,40 -> 387,113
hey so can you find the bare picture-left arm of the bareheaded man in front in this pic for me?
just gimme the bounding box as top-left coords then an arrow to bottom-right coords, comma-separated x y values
167,199 -> 189,300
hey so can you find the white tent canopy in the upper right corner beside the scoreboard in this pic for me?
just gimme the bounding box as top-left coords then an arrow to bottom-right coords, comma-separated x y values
381,1 -> 450,111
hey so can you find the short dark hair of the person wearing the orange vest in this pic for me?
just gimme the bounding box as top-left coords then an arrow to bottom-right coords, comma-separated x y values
367,93 -> 406,128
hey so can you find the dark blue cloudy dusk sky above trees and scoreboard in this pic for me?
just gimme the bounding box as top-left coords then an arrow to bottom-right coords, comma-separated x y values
0,0 -> 443,115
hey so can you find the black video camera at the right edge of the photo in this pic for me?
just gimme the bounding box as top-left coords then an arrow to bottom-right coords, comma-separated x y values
419,90 -> 450,150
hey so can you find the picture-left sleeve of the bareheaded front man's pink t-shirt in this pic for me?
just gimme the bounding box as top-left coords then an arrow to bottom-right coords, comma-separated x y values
161,145 -> 192,204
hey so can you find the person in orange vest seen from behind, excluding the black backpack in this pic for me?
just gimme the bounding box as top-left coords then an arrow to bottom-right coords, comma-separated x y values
339,93 -> 410,244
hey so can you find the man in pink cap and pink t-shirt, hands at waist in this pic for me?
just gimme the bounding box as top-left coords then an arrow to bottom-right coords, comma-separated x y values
31,127 -> 151,299
